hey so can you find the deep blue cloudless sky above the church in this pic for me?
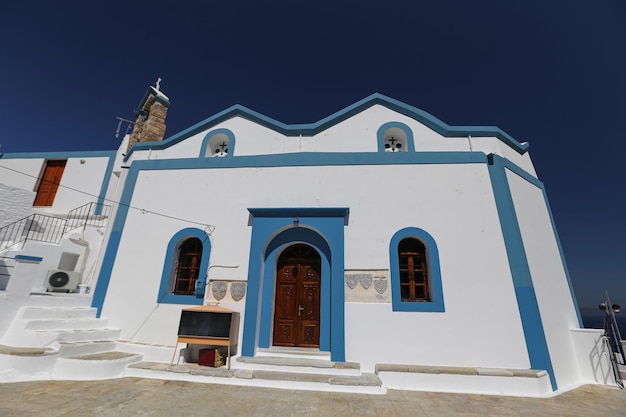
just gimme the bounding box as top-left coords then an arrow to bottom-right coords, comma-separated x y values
0,0 -> 626,307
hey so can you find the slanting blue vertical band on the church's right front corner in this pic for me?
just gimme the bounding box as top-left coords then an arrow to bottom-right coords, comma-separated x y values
488,155 -> 558,391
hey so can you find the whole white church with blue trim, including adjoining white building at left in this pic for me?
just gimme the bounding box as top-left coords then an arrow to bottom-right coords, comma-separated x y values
0,86 -> 615,396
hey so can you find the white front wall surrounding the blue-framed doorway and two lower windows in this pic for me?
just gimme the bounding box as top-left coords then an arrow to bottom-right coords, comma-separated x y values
102,164 -> 529,370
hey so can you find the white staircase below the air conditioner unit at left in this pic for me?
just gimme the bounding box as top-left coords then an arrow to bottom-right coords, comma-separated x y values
0,294 -> 142,381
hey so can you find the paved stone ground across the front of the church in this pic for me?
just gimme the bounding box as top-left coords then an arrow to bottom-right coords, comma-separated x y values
0,378 -> 626,417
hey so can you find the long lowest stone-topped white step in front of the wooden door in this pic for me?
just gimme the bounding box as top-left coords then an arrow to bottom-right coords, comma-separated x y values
125,362 -> 386,394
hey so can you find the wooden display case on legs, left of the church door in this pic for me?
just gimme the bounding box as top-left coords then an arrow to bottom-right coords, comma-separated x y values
170,305 -> 239,369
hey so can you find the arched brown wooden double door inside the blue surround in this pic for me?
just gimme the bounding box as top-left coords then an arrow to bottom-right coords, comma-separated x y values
273,244 -> 322,348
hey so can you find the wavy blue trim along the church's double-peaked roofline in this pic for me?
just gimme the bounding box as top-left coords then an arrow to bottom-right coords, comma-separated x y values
125,93 -> 528,160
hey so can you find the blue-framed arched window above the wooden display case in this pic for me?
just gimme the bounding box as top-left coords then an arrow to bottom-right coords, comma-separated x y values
157,227 -> 211,305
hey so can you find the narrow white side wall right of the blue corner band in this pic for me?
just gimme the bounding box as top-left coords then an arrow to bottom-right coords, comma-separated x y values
506,170 -> 580,387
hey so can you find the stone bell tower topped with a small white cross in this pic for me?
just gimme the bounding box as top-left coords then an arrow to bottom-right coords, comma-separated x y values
128,78 -> 170,150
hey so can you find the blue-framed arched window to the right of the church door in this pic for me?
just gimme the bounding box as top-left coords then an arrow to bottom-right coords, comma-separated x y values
389,227 -> 445,312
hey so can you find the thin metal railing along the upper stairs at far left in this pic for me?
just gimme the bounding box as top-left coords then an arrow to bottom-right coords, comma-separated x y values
0,203 -> 111,251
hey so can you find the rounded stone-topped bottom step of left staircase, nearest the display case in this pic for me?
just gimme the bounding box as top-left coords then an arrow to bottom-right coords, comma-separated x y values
52,351 -> 142,381
